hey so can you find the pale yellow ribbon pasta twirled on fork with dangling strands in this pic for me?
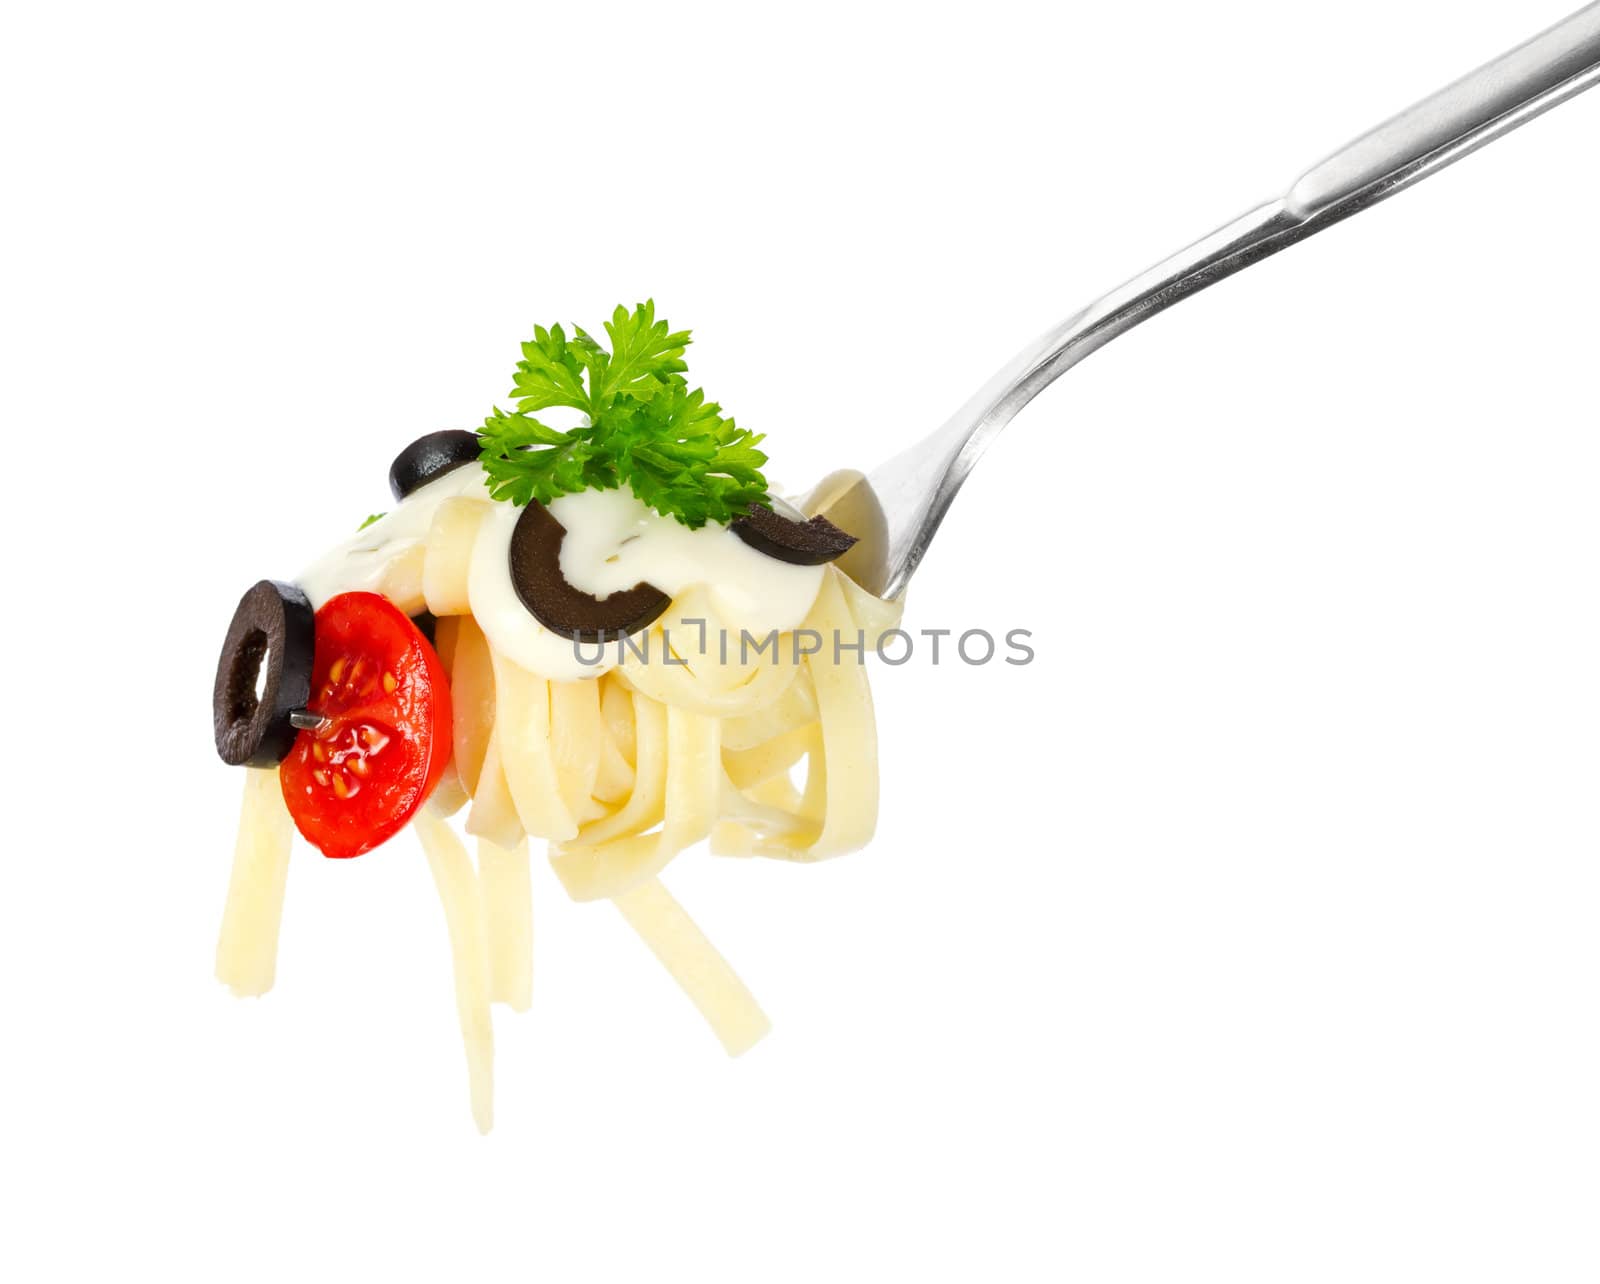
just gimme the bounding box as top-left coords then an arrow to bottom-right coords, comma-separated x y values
218,483 -> 899,1130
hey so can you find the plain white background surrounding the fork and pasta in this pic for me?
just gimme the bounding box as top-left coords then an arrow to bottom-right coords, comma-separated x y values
0,0 -> 1600,1281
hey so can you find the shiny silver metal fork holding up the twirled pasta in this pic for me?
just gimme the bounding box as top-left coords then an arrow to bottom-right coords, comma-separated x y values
825,3 -> 1600,597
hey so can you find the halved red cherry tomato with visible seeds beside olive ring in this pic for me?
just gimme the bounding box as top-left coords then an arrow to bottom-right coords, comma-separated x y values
278,592 -> 451,857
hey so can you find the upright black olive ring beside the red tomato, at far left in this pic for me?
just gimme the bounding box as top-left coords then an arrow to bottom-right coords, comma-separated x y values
211,580 -> 314,767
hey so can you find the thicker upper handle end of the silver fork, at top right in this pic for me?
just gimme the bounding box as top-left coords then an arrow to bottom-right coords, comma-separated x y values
1286,3 -> 1600,219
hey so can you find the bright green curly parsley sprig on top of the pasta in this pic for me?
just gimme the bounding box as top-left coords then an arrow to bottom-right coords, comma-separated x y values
480,299 -> 768,528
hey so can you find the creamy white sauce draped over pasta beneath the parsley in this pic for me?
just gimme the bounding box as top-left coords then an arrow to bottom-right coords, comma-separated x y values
299,464 -> 824,679
